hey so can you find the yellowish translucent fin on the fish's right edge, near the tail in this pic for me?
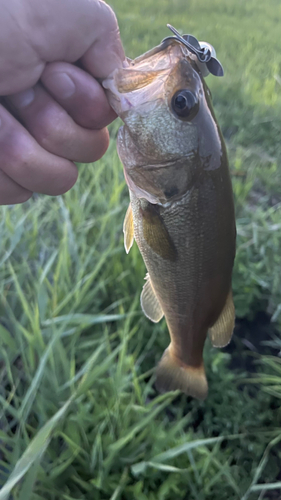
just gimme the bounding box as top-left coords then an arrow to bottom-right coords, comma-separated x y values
209,290 -> 235,347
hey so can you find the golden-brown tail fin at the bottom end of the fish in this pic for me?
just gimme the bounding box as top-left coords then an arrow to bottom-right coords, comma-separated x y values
156,346 -> 208,399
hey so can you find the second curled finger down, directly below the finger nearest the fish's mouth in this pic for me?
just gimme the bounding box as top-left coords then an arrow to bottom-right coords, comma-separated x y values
7,84 -> 109,163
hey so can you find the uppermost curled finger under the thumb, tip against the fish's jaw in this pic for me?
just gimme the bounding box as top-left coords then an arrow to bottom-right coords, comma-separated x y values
41,62 -> 116,129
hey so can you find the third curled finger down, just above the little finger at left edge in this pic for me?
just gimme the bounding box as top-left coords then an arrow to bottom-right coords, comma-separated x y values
0,105 -> 77,195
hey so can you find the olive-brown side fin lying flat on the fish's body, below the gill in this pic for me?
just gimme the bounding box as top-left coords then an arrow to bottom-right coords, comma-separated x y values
142,206 -> 177,261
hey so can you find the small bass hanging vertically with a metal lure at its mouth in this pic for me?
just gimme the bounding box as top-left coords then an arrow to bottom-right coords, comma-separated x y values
103,34 -> 236,400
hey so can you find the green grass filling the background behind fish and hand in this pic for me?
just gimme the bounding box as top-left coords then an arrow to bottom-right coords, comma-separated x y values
0,0 -> 281,500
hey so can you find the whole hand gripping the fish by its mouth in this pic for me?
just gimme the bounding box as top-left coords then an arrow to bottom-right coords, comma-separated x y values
0,0 -> 125,205
